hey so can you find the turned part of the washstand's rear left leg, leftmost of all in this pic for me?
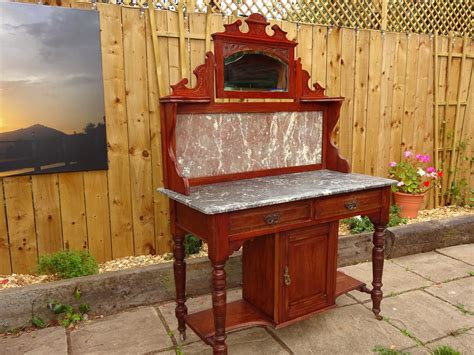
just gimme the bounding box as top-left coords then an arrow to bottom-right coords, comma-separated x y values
173,232 -> 188,340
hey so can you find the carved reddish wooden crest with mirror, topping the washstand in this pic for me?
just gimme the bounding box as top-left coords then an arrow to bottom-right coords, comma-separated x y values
161,14 -> 327,102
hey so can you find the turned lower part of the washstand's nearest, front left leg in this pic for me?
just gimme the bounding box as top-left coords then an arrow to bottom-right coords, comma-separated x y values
212,262 -> 227,355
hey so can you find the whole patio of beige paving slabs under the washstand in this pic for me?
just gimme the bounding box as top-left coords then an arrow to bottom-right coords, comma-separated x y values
0,244 -> 474,355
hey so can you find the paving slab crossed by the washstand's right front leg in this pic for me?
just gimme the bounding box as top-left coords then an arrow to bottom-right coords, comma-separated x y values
340,260 -> 433,301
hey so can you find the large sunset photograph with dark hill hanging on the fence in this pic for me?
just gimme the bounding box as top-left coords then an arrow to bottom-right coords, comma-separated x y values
0,2 -> 107,177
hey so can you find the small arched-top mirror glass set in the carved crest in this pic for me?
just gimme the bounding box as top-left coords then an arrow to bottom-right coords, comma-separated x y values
224,51 -> 288,92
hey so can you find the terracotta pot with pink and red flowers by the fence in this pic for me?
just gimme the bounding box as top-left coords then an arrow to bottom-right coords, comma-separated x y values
388,151 -> 443,218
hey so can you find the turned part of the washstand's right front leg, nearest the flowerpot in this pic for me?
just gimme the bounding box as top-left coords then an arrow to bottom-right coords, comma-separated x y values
370,225 -> 385,320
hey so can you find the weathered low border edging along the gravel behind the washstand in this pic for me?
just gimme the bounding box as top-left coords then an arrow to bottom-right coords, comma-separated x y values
0,215 -> 474,332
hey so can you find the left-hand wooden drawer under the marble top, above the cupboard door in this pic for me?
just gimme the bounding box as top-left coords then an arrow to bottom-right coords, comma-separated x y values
229,201 -> 312,235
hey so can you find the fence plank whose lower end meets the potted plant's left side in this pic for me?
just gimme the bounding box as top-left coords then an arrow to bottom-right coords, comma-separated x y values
389,33 -> 408,162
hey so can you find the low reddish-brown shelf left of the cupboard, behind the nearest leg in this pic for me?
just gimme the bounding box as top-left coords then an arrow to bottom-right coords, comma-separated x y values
185,300 -> 274,344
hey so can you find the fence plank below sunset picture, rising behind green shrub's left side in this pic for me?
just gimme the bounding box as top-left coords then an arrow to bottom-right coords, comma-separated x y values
31,174 -> 63,256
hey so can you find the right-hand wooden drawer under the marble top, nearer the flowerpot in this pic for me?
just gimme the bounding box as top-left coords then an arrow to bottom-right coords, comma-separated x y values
314,189 -> 382,219
